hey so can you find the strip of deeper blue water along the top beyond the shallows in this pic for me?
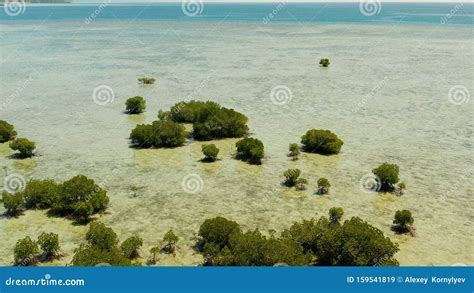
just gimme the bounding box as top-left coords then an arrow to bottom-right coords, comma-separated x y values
0,3 -> 474,25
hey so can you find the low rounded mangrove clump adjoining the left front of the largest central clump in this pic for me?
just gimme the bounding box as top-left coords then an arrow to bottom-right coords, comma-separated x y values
130,120 -> 186,148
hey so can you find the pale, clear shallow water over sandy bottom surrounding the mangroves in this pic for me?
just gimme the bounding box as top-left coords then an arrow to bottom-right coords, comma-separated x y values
0,5 -> 474,265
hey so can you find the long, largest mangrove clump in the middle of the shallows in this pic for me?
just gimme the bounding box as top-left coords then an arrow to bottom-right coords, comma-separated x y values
168,100 -> 248,140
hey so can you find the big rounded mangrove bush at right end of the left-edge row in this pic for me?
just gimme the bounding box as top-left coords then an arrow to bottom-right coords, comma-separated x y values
53,175 -> 109,222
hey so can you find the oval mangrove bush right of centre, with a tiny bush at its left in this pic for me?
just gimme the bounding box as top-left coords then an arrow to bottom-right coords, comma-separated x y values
301,129 -> 344,155
